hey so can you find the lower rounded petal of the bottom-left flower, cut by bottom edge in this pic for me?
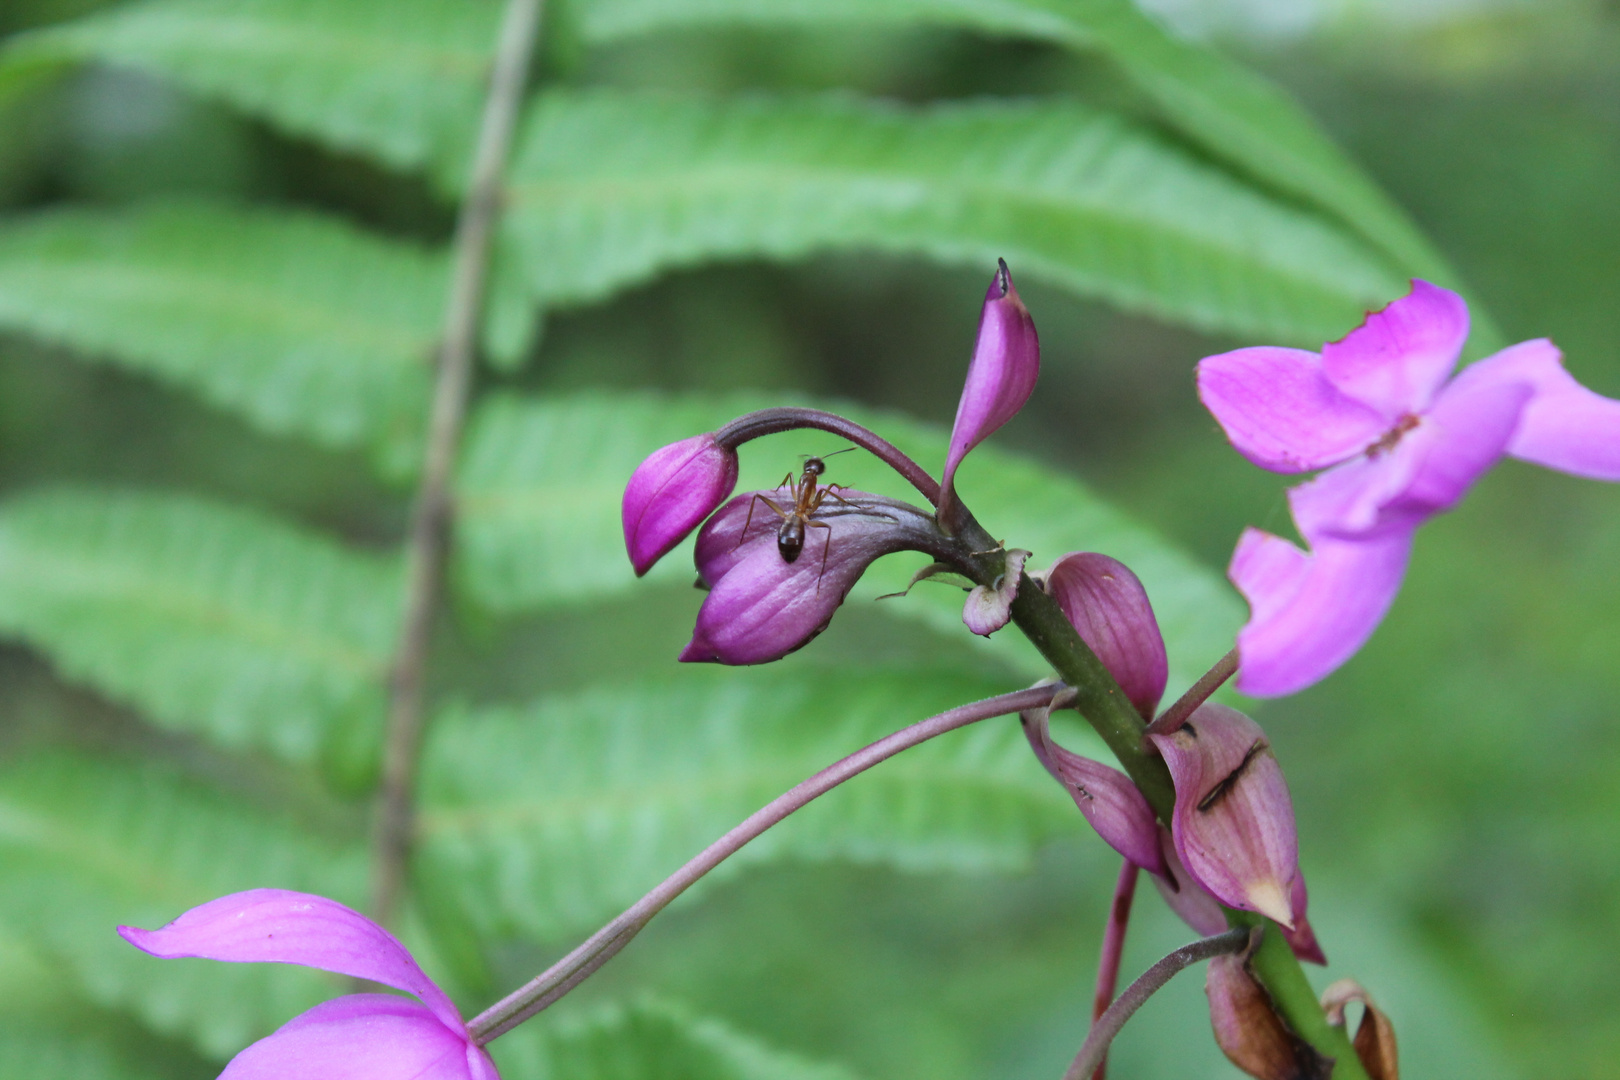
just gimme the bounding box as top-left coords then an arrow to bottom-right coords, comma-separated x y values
220,994 -> 496,1080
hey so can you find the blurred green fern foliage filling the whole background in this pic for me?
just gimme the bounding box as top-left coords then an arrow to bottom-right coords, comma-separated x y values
0,0 -> 1620,1080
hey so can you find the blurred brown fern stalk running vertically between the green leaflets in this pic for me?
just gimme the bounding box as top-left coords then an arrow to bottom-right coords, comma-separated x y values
371,0 -> 543,923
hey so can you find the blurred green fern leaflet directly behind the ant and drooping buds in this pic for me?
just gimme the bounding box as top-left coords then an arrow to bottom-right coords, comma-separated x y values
457,393 -> 1243,683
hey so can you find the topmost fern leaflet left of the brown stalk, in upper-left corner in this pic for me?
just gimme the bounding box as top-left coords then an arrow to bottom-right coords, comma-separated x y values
0,0 -> 501,188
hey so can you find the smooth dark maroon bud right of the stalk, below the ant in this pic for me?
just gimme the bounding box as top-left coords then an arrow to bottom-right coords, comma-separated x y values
1047,552 -> 1170,721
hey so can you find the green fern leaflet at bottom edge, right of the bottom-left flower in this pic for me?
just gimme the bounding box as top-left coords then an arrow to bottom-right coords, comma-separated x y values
489,1001 -> 851,1080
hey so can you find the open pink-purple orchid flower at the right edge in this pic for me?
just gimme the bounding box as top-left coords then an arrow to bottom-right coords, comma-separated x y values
1199,280 -> 1620,696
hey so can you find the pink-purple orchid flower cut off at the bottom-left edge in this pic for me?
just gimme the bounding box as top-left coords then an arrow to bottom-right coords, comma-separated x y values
118,889 -> 499,1080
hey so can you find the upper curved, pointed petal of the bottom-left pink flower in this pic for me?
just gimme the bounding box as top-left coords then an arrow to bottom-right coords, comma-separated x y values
118,889 -> 463,1031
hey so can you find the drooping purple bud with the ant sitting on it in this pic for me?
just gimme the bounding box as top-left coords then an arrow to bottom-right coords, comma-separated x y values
680,489 -> 938,664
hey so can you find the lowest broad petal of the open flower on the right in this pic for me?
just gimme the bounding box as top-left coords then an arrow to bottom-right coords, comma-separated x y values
1226,529 -> 1413,698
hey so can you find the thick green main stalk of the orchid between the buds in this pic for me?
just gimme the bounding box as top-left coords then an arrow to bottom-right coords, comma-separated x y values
997,579 -> 1367,1080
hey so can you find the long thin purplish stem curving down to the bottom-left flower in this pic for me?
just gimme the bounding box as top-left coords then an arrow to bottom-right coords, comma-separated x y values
467,683 -> 1063,1044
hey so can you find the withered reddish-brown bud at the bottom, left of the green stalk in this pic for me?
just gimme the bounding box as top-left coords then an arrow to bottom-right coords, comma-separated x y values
1204,954 -> 1333,1080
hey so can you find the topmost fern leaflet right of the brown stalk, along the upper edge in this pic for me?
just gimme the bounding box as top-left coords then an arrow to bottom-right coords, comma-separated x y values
577,0 -> 1455,296
